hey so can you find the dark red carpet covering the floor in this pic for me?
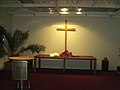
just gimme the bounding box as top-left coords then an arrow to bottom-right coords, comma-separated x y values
0,69 -> 120,90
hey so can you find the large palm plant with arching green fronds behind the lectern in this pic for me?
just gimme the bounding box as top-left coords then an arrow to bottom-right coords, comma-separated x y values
0,26 -> 46,70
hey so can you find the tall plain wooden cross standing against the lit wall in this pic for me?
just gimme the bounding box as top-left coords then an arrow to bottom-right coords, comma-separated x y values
57,20 -> 76,50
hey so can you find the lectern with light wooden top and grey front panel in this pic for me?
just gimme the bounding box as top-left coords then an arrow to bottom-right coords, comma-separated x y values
9,56 -> 34,90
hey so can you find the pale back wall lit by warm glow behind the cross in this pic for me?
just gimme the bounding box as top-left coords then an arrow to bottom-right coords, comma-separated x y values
12,16 -> 120,70
